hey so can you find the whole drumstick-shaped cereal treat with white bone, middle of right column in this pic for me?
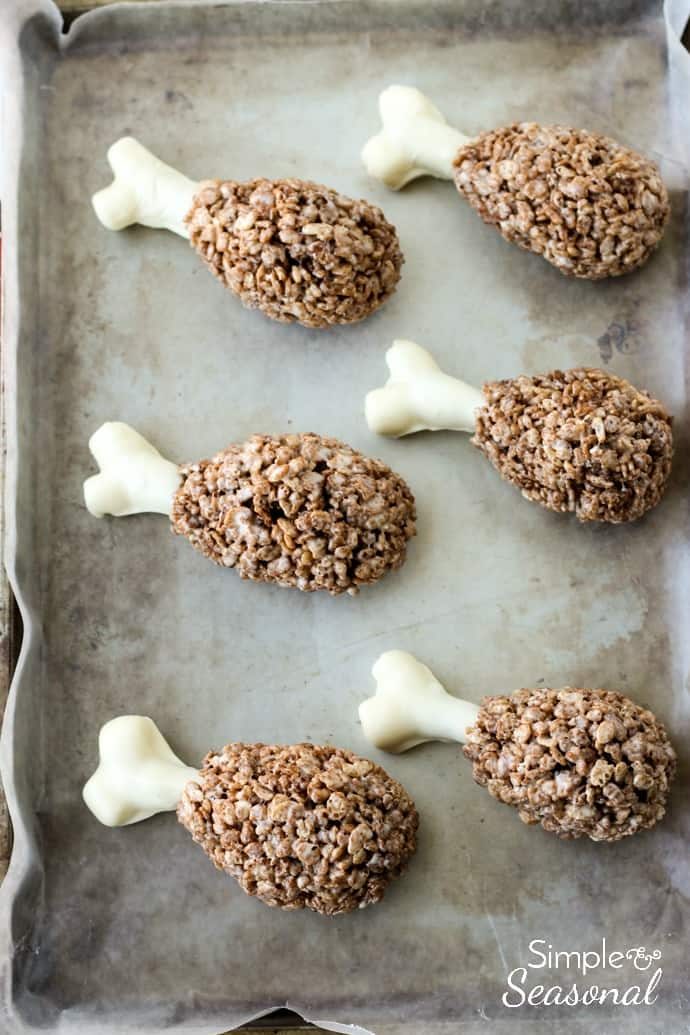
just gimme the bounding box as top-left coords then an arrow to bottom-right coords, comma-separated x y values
365,341 -> 673,525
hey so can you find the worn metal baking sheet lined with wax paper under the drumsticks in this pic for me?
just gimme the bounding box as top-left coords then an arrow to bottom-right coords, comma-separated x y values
0,0 -> 690,1035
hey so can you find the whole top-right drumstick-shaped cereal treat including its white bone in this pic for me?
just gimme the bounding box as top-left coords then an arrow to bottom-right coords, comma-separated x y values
362,86 -> 668,280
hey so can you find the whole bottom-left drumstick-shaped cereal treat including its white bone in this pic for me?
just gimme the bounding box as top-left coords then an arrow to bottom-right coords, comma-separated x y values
84,715 -> 419,916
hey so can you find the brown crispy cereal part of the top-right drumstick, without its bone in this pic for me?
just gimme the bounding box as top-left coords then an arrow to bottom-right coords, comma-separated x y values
453,122 -> 669,280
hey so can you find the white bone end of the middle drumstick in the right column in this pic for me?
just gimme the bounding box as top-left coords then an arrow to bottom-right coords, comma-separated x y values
364,341 -> 486,438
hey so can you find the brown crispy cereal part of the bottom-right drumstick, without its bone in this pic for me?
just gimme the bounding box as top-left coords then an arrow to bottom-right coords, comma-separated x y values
463,686 -> 676,841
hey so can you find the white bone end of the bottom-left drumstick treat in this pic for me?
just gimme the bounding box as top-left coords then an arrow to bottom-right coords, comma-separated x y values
83,715 -> 199,827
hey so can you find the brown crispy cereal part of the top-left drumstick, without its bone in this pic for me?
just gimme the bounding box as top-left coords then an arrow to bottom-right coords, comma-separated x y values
186,179 -> 403,327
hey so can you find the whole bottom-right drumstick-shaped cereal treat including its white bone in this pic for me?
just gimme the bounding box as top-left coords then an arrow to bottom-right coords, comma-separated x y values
359,650 -> 676,841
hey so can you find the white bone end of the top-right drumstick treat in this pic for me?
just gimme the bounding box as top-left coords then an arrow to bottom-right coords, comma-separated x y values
362,86 -> 470,190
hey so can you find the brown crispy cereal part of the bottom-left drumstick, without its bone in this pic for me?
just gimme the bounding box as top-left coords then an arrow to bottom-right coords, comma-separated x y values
177,744 -> 419,916
